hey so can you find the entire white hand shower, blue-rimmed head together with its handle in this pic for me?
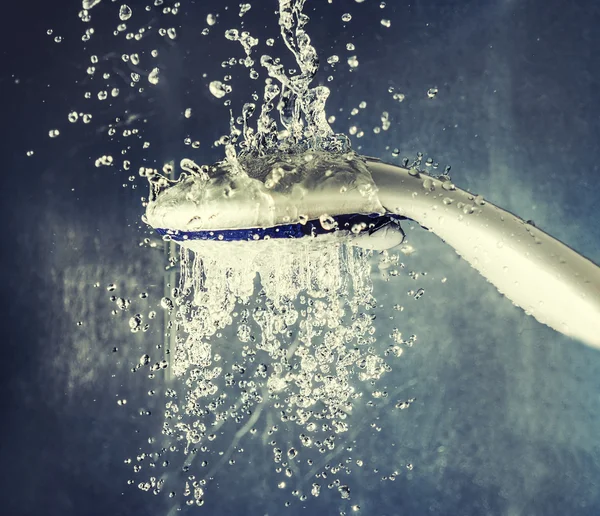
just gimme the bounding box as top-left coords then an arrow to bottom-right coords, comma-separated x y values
146,152 -> 600,348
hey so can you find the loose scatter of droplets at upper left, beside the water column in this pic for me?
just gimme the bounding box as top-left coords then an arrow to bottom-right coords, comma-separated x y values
35,0 -> 191,202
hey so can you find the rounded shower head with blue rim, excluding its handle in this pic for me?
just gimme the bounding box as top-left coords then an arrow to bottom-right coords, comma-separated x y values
146,151 -> 404,250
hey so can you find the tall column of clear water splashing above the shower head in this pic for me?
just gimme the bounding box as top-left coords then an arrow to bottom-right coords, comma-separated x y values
209,0 -> 341,161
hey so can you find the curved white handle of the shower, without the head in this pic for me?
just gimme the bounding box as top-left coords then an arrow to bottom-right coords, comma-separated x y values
367,158 -> 600,349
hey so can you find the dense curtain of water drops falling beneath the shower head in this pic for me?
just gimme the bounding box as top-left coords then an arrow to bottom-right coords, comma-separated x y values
135,241 -> 408,507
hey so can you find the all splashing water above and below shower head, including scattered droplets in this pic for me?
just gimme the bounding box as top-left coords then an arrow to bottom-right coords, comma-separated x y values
58,0 -> 412,510
